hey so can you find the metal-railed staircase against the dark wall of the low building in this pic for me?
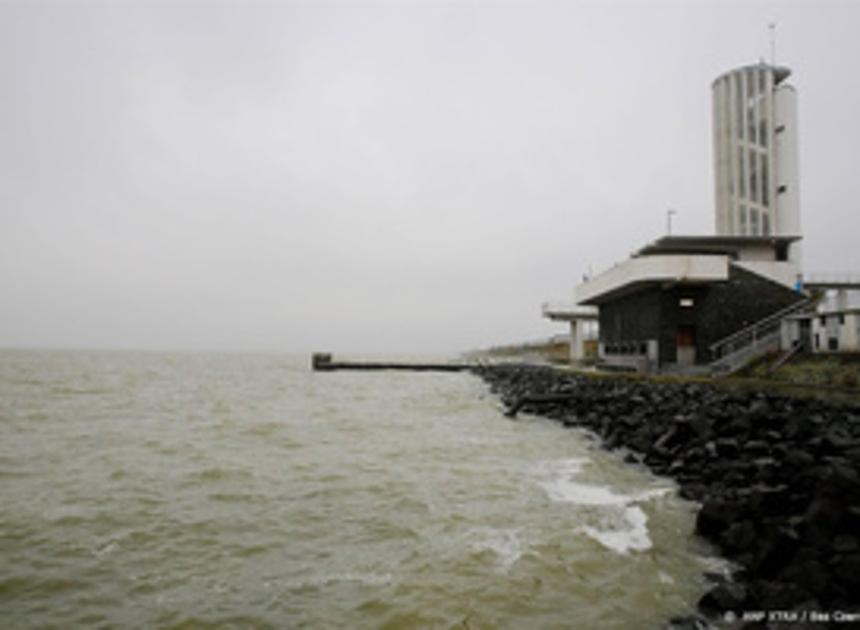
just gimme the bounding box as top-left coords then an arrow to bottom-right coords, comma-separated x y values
708,298 -> 817,375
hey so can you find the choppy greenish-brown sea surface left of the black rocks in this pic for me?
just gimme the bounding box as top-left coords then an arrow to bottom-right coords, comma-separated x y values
0,350 -> 718,629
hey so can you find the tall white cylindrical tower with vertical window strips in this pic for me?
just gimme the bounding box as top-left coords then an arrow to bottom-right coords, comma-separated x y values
711,63 -> 801,264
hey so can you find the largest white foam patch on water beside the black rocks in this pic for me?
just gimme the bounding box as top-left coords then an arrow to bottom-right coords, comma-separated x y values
539,459 -> 669,553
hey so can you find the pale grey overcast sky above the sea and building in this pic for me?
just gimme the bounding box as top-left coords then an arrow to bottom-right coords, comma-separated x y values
0,0 -> 860,353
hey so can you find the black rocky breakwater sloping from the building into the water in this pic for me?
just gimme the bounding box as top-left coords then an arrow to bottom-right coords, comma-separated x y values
477,365 -> 860,627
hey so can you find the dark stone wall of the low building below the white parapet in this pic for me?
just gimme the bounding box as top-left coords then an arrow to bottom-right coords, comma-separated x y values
600,266 -> 802,365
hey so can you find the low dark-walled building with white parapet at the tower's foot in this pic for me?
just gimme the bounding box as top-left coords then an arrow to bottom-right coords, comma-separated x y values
576,236 -> 808,372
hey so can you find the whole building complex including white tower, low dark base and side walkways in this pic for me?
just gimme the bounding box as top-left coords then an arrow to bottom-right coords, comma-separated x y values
545,63 -> 860,374
